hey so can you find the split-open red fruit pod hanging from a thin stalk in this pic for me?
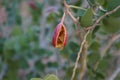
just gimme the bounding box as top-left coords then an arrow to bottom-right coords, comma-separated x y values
52,23 -> 68,49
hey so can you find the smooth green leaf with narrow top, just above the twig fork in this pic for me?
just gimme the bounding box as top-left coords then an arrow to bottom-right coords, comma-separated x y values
80,8 -> 93,27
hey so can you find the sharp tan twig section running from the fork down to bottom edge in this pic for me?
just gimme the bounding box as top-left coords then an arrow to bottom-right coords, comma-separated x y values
71,30 -> 90,80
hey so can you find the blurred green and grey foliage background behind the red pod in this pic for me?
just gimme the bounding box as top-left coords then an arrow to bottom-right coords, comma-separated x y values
0,0 -> 120,80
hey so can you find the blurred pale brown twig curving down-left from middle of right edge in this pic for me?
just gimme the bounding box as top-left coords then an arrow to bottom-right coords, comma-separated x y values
94,34 -> 120,70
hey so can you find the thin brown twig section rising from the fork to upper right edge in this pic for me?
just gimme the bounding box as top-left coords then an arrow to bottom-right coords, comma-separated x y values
86,6 -> 120,30
